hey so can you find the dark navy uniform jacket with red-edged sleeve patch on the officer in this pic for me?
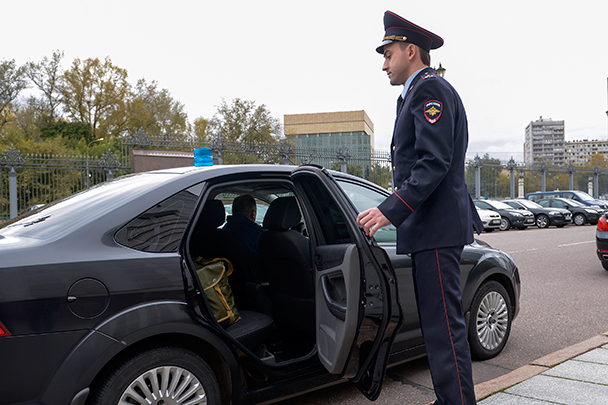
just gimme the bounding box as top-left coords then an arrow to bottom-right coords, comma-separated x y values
378,68 -> 483,253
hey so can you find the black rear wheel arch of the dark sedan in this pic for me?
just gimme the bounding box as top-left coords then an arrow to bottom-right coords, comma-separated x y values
38,301 -> 242,403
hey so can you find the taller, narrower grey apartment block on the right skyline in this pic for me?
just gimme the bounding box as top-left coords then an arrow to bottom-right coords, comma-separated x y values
524,117 -> 566,165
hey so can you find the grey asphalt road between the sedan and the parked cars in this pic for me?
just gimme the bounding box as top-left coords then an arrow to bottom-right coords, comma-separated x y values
280,225 -> 608,405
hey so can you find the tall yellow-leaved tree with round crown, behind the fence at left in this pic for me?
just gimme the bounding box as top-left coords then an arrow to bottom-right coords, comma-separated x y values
59,57 -> 130,139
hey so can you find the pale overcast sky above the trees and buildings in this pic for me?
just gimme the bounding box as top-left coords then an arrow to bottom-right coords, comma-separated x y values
0,0 -> 608,161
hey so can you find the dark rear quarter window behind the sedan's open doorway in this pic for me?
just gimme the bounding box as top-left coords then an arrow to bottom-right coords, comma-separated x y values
116,187 -> 200,253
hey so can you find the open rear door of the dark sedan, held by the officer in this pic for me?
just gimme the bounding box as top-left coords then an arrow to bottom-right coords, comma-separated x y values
292,165 -> 401,400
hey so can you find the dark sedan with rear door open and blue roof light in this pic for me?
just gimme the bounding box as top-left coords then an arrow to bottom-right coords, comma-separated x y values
0,165 -> 520,405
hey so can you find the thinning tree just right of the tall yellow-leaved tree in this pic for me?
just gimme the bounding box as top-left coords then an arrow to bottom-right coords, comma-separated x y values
128,79 -> 188,138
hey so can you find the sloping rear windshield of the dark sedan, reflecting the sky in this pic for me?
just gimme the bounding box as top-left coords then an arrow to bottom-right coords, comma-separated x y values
0,171 -> 176,239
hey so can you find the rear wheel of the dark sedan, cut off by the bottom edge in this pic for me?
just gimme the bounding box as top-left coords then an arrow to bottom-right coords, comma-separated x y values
87,346 -> 221,405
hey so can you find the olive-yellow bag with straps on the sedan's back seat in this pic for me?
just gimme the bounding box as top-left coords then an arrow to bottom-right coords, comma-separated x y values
196,257 -> 241,327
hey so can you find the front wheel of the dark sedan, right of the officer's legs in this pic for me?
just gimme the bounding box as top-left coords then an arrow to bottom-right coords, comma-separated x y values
469,280 -> 513,360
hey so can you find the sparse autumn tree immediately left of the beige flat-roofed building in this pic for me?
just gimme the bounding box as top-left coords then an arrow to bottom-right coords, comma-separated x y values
209,98 -> 282,145
